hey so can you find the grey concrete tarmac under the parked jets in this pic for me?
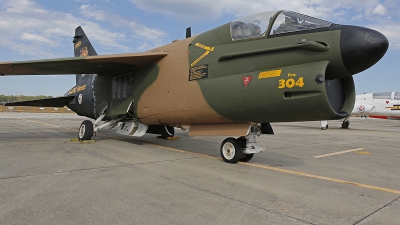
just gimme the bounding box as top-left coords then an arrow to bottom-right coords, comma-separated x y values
0,113 -> 400,225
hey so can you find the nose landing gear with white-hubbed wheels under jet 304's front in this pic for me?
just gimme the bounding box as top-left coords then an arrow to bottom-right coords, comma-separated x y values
220,126 -> 267,163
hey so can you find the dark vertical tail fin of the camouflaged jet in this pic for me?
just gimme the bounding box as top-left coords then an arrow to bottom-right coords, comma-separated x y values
72,26 -> 97,85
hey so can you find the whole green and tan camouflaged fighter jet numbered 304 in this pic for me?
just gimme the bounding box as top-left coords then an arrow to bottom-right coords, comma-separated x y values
0,11 -> 389,163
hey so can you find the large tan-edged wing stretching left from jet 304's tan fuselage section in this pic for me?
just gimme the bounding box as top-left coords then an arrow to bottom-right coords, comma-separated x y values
0,52 -> 168,76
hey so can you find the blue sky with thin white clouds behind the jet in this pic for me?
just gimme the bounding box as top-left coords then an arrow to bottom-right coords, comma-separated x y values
0,0 -> 400,96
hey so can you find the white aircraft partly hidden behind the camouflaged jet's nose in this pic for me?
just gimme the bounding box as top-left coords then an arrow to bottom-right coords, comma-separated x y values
321,92 -> 400,130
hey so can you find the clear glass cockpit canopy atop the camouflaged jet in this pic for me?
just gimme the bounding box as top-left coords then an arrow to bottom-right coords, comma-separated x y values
231,11 -> 332,41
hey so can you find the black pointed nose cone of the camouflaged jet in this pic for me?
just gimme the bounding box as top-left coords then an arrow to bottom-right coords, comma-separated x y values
340,26 -> 389,74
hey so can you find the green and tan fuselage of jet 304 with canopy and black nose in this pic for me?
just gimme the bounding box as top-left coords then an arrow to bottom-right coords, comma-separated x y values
65,11 -> 388,127
